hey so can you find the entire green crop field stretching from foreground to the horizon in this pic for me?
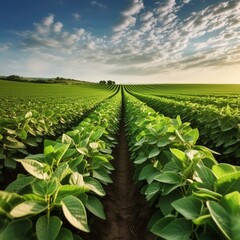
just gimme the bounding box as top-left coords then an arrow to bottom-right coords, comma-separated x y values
0,80 -> 240,240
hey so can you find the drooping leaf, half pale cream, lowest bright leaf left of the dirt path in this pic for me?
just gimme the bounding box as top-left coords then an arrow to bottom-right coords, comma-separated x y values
61,196 -> 89,232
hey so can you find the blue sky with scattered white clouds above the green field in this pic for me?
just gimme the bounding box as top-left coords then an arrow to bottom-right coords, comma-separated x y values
0,0 -> 240,84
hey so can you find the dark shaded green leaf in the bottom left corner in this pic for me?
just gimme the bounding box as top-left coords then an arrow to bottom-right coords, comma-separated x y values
0,218 -> 33,240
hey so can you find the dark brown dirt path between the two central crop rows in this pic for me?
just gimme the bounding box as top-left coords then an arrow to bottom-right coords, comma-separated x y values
90,102 -> 154,240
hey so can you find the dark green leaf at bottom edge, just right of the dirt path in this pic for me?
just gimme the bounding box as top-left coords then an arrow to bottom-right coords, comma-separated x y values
150,217 -> 193,240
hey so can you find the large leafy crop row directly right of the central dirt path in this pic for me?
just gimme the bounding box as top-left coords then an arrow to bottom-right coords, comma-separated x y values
125,91 -> 240,240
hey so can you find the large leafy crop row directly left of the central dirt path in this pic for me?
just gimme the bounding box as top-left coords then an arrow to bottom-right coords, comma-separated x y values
0,93 -> 121,240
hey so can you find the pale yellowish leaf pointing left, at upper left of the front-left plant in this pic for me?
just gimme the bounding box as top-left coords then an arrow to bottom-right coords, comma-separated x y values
17,159 -> 50,180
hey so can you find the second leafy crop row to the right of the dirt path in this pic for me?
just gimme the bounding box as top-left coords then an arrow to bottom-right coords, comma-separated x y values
129,94 -> 240,164
